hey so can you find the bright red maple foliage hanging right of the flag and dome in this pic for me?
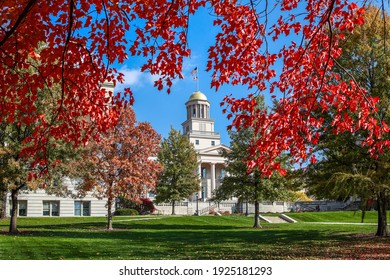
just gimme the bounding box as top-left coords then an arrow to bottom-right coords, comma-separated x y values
218,1 -> 390,175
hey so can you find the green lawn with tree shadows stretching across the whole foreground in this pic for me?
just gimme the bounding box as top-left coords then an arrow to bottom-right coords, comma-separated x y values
0,212 -> 390,260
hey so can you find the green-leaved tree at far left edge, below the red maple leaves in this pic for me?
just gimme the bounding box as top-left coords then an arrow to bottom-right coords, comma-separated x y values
0,119 -> 78,234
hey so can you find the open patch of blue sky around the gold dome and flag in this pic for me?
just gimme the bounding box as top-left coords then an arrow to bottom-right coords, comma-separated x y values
117,5 -> 272,145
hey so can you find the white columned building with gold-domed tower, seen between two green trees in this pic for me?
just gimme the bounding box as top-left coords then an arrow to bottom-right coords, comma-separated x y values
182,91 -> 229,200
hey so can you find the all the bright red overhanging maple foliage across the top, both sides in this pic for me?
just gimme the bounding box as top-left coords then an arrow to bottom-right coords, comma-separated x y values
0,0 -> 390,178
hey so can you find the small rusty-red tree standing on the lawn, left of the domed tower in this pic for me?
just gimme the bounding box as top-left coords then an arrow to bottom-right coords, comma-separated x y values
80,108 -> 161,230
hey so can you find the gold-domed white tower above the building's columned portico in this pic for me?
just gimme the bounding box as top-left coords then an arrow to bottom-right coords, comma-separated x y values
182,91 -> 221,150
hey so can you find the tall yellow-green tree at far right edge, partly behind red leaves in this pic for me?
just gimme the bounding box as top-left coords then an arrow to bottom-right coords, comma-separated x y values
307,6 -> 390,236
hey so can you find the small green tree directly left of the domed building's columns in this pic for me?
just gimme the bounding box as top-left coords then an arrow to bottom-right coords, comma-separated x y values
156,128 -> 200,215
